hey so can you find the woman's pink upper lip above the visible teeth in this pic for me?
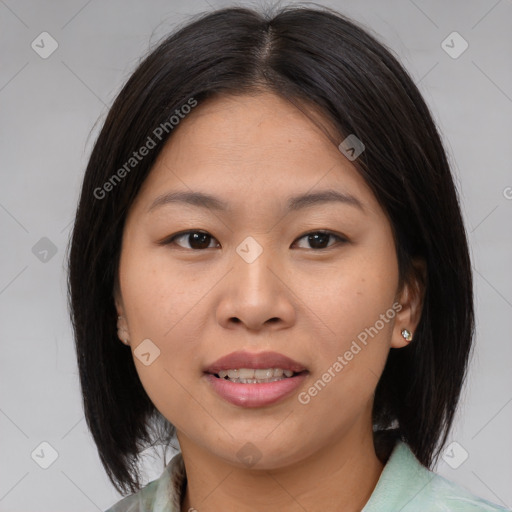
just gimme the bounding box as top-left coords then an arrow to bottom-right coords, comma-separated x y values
203,351 -> 307,375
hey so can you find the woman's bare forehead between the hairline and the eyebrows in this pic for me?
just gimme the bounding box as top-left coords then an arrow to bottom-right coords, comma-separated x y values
130,93 -> 376,217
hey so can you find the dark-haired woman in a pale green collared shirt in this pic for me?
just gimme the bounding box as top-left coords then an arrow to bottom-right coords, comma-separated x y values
69,7 -> 505,512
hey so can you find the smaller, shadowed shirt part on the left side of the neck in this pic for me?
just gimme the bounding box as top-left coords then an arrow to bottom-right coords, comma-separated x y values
105,453 -> 185,512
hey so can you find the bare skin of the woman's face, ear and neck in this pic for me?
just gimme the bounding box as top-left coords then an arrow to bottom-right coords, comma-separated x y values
115,92 -> 422,512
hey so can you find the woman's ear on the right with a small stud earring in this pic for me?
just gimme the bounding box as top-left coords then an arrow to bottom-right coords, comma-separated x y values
391,258 -> 427,348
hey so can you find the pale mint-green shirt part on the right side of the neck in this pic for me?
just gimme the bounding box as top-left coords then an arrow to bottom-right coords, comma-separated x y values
362,441 -> 510,512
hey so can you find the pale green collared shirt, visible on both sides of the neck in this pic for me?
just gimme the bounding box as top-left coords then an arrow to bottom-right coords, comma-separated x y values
106,441 -> 511,512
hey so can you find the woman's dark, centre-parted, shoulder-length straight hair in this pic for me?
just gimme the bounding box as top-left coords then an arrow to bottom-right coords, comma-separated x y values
69,2 -> 474,493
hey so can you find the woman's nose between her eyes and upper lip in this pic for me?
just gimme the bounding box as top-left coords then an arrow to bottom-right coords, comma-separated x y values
217,243 -> 296,331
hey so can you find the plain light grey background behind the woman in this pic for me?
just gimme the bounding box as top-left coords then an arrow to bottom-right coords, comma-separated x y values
0,0 -> 512,512
